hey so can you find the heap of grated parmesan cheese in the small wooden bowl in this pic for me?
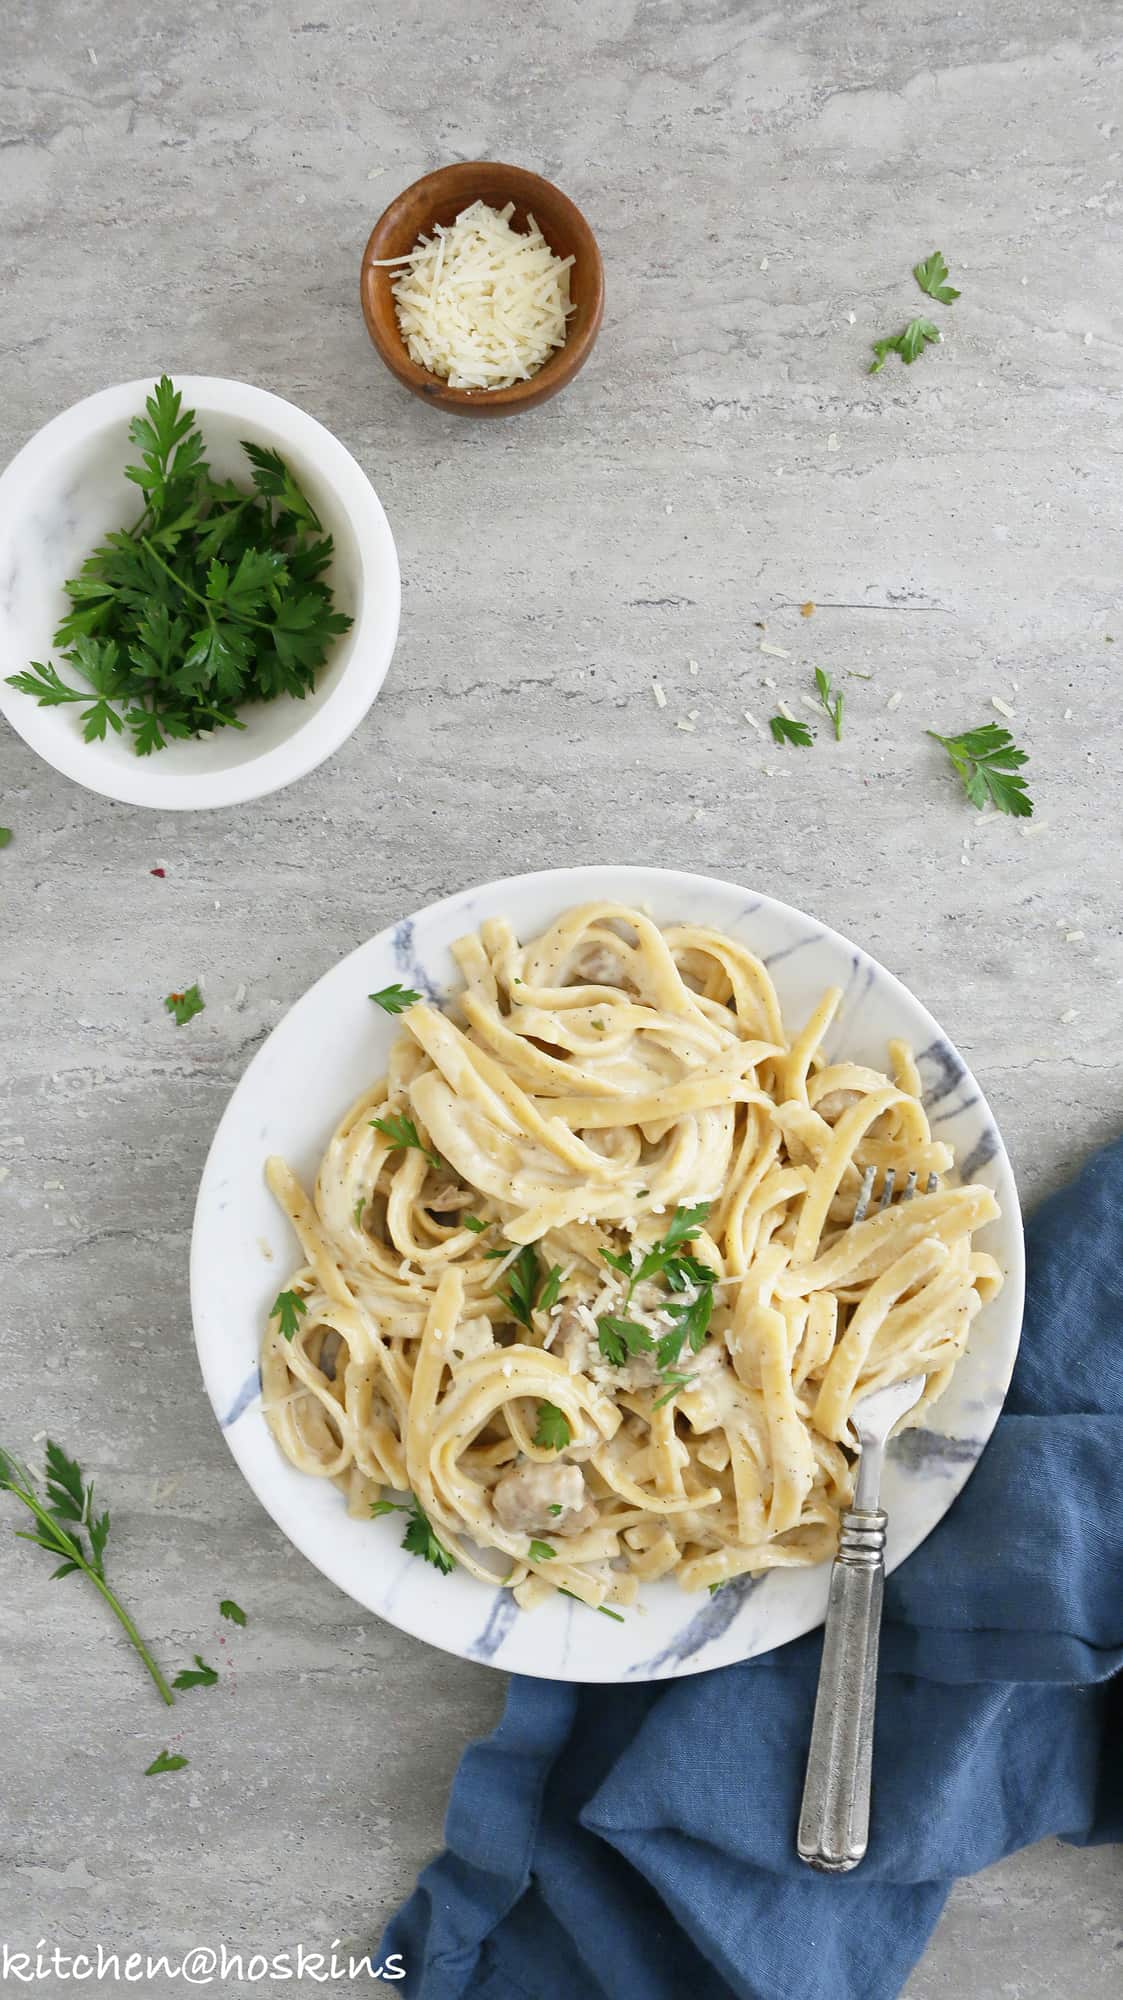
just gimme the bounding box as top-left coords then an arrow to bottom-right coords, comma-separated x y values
380,202 -> 575,390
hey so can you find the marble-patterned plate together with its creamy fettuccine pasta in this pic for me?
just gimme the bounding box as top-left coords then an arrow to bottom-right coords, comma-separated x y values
192,866 -> 1023,1680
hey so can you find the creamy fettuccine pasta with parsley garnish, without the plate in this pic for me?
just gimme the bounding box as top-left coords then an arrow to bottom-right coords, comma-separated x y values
262,904 -> 1001,1608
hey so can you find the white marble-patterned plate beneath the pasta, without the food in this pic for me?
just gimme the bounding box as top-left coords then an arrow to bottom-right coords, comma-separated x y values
192,866 -> 1023,1680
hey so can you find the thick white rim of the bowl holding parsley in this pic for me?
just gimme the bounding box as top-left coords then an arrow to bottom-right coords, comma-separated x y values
0,374 -> 402,812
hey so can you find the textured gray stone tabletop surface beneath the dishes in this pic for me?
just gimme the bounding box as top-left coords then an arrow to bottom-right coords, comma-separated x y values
0,0 -> 1123,2000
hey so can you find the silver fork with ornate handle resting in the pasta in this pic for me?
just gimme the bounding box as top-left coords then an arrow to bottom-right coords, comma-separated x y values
795,1166 -> 937,1874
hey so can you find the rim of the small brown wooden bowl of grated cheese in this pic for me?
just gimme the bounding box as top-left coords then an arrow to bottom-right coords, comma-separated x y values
360,160 -> 603,416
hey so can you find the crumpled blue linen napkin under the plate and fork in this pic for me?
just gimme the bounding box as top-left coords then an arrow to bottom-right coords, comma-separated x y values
380,1140 -> 1123,2000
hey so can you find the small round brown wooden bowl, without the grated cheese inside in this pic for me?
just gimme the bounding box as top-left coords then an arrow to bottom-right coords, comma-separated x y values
360,160 -> 603,416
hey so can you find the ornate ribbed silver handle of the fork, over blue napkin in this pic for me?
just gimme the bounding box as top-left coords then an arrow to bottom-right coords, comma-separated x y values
797,1508 -> 885,1874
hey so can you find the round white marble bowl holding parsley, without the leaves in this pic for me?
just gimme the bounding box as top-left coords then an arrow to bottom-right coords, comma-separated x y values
0,376 -> 402,812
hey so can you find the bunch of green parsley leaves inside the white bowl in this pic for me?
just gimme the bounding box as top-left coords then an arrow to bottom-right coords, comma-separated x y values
8,376 -> 352,756
